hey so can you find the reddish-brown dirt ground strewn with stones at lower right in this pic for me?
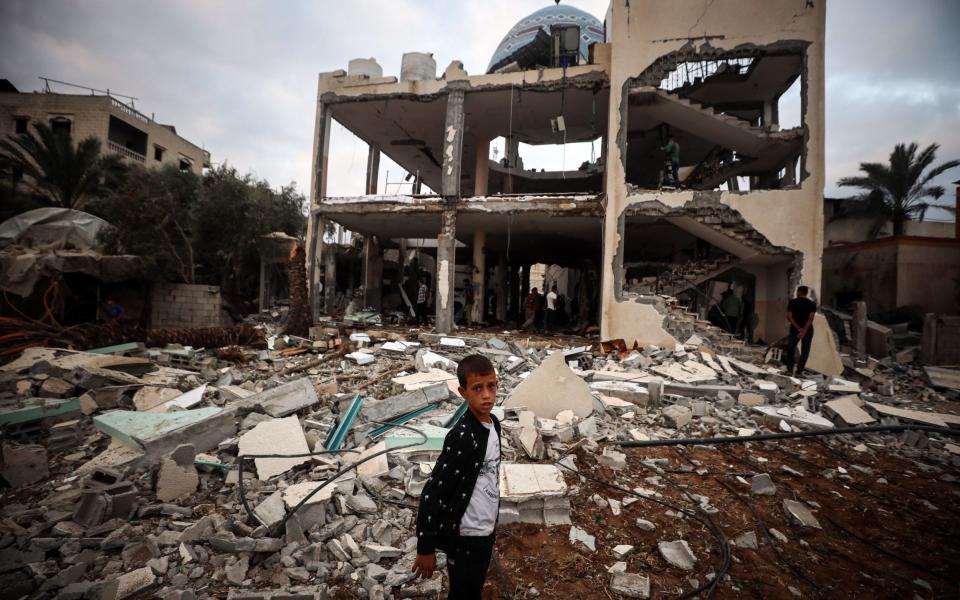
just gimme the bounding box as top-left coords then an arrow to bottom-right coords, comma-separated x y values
484,438 -> 960,599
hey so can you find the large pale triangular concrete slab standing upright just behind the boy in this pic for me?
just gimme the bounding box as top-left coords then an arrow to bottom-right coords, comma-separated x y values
503,352 -> 593,419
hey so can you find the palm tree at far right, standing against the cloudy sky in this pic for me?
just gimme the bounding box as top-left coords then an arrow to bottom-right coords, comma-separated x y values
839,143 -> 960,235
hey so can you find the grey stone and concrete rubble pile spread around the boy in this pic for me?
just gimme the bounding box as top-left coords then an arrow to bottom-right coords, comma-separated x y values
0,310 -> 960,600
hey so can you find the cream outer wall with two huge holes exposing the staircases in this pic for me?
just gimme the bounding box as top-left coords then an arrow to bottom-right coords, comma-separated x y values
601,0 -> 826,343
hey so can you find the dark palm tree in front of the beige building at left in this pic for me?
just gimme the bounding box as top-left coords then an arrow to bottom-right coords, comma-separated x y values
0,123 -> 120,209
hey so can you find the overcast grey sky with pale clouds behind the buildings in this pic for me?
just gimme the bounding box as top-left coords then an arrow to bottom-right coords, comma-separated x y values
0,0 -> 960,217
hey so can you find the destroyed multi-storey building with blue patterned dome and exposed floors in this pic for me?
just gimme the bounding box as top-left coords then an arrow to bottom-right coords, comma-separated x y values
308,0 -> 825,343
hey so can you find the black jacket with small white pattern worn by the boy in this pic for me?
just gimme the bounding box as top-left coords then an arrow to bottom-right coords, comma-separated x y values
417,410 -> 503,554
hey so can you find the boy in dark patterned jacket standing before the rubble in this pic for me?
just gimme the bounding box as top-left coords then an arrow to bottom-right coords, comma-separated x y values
413,354 -> 500,600
